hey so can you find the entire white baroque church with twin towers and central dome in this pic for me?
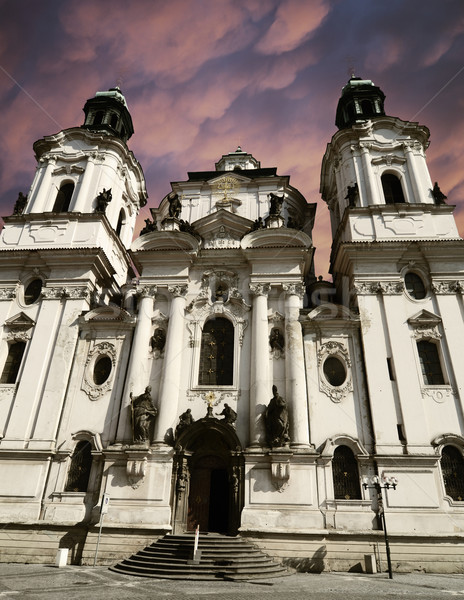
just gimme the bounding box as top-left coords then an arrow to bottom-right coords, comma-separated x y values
0,77 -> 464,572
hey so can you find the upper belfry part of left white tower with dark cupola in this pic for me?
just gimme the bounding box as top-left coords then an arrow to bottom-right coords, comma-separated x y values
0,88 -> 147,286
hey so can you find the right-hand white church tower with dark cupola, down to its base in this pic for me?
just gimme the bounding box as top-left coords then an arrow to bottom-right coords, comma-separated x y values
321,77 -> 464,531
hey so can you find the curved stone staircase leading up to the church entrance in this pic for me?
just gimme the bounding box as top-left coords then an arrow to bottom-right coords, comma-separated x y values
110,533 -> 291,580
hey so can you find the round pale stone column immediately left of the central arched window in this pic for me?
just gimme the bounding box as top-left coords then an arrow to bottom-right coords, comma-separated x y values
155,285 -> 187,444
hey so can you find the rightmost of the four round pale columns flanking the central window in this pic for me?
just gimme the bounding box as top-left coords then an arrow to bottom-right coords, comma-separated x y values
282,283 -> 310,448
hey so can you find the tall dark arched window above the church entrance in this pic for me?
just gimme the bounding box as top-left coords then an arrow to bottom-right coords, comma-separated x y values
198,317 -> 234,385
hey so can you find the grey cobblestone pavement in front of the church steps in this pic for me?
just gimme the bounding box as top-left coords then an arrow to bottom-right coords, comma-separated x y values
0,564 -> 464,600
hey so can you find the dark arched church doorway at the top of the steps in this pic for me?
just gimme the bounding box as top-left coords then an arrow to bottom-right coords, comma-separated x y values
172,417 -> 243,535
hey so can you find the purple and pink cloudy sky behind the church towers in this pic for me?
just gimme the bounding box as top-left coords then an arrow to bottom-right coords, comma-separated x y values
0,0 -> 464,276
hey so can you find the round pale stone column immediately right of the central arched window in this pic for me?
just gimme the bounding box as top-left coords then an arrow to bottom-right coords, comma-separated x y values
249,283 -> 272,446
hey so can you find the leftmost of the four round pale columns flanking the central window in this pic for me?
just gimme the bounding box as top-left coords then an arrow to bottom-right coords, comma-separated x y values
116,285 -> 156,442
